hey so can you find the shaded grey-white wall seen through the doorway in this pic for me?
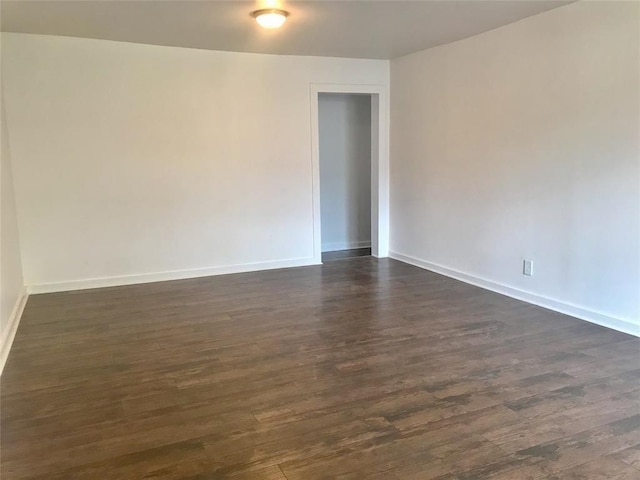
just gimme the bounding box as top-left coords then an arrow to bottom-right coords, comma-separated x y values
318,93 -> 371,252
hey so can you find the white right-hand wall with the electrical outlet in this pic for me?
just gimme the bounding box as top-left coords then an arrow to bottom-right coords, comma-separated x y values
391,2 -> 640,334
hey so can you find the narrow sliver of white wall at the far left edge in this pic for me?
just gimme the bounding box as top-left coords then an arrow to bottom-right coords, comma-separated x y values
0,91 -> 26,371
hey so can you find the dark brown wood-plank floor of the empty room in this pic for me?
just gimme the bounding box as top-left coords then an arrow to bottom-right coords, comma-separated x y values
1,257 -> 640,480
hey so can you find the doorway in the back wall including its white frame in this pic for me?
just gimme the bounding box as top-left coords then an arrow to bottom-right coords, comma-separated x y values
311,85 -> 389,263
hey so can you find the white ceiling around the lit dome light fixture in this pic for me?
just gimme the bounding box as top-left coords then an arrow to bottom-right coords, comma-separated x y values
1,0 -> 571,59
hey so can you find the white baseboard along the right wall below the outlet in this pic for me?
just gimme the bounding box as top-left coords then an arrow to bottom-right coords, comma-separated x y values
389,252 -> 640,337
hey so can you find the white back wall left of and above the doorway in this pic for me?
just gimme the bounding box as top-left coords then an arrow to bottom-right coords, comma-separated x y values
2,34 -> 389,291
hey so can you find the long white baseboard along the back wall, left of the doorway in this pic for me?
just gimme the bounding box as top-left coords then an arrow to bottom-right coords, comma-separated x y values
28,257 -> 318,294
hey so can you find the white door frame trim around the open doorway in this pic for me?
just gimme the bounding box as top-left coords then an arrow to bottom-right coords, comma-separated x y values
311,84 -> 389,264
